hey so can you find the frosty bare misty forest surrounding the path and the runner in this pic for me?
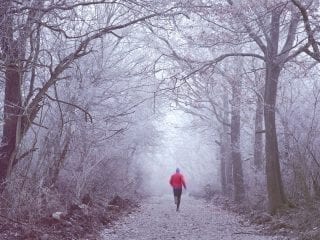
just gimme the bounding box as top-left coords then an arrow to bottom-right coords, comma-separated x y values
0,0 -> 320,239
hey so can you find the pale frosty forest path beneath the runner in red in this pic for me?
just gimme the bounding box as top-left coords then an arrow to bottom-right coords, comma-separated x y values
102,195 -> 292,240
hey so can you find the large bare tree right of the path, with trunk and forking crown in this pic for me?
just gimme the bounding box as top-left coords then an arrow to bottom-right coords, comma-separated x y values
196,1 -> 312,213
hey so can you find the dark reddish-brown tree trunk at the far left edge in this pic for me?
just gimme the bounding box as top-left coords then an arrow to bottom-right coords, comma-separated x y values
0,1 -> 22,189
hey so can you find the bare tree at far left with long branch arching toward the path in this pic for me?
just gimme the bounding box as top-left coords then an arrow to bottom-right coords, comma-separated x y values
0,0 -> 176,188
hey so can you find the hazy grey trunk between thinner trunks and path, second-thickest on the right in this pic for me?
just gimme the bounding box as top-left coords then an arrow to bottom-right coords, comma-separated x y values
231,81 -> 245,202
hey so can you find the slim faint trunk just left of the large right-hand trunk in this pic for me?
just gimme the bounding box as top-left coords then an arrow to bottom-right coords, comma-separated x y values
253,90 -> 263,170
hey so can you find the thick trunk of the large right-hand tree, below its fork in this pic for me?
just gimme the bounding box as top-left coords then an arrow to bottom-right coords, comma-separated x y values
264,62 -> 287,214
